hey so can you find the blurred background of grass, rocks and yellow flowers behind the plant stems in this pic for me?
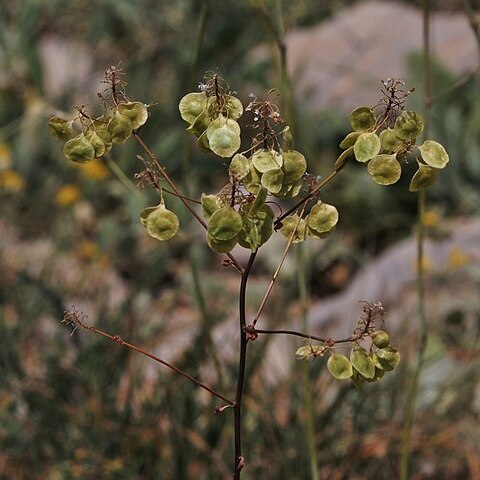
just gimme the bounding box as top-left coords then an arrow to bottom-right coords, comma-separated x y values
0,0 -> 480,480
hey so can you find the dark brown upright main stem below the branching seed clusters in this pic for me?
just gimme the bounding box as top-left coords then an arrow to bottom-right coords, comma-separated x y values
233,252 -> 257,480
